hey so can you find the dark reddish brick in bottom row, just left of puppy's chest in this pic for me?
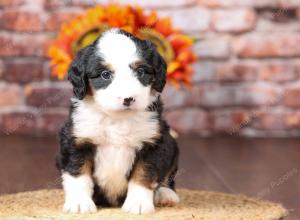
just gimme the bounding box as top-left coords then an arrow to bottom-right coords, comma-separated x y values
38,111 -> 68,135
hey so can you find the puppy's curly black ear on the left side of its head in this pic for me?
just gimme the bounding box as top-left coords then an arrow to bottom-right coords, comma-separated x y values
68,46 -> 91,100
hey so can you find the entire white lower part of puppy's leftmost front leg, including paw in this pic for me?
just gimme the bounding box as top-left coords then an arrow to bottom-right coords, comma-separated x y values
62,173 -> 97,213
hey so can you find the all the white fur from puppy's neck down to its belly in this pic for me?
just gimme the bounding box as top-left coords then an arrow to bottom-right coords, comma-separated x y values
72,99 -> 159,203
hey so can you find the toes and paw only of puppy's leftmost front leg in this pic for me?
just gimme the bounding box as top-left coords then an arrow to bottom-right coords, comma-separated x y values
63,198 -> 97,214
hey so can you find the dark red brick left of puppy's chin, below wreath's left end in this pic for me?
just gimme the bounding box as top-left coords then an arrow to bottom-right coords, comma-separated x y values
26,85 -> 72,109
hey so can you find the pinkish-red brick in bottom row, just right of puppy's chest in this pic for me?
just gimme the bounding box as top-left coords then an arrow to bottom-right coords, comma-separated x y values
165,109 -> 211,135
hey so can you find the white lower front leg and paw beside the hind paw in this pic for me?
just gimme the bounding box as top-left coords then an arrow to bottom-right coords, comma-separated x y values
122,182 -> 154,214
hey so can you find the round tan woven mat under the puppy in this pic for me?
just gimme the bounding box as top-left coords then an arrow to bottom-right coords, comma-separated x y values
0,189 -> 287,220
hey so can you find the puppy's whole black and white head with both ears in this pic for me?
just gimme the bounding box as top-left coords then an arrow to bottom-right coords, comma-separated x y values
68,29 -> 166,112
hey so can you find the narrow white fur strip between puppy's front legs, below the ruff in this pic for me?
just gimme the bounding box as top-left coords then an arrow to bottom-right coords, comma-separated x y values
93,146 -> 135,204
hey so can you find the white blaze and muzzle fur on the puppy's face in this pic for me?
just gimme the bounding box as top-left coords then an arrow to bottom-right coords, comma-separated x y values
95,29 -> 151,112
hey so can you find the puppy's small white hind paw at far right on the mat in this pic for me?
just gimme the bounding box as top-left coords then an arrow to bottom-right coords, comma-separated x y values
154,187 -> 179,206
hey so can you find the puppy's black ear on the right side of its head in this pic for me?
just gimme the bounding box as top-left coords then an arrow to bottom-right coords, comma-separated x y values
150,42 -> 167,92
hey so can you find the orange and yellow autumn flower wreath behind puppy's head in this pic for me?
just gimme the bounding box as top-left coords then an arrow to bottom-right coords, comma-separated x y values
48,4 -> 195,86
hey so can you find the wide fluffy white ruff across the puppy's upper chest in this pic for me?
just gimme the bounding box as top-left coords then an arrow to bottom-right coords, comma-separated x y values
73,99 -> 159,148
